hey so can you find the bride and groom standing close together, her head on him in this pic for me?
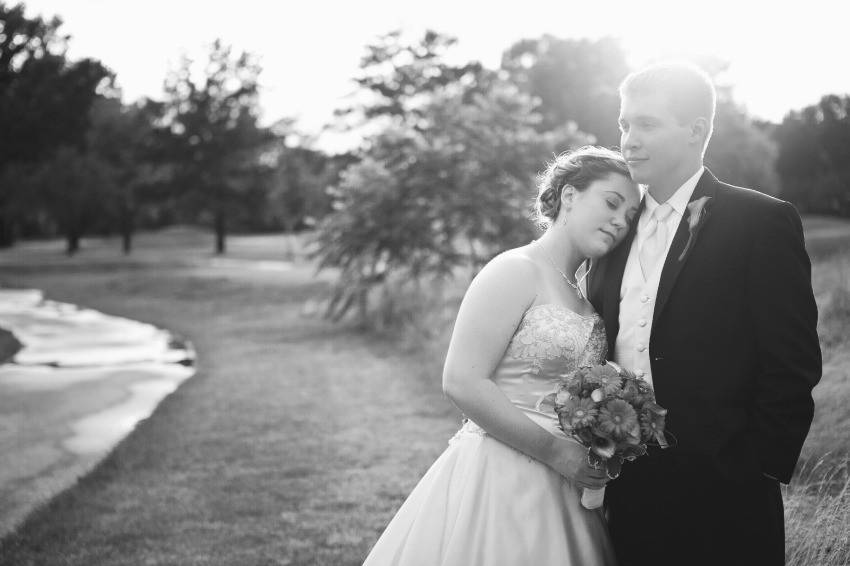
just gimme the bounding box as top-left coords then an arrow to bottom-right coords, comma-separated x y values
366,63 -> 821,566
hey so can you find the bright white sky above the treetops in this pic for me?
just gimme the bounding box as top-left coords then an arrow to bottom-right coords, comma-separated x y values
18,0 -> 850,153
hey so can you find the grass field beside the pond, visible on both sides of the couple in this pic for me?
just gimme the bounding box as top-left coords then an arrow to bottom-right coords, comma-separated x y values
0,219 -> 850,566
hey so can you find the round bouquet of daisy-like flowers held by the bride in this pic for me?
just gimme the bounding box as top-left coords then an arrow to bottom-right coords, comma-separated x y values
536,362 -> 668,509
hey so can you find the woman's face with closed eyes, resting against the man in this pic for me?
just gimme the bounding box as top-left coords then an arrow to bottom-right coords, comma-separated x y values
564,173 -> 640,257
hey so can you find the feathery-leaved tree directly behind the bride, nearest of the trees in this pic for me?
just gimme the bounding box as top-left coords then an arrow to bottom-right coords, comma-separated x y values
317,38 -> 587,323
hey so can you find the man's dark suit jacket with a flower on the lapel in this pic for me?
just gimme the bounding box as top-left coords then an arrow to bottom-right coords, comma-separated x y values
588,169 -> 821,483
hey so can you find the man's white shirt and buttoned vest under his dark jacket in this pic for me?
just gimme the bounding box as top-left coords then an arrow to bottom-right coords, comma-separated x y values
614,167 -> 705,384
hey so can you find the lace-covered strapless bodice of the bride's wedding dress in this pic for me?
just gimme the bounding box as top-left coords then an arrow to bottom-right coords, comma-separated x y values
493,304 -> 607,416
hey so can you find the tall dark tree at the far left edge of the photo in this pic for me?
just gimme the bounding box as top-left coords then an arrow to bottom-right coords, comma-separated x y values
0,2 -> 112,246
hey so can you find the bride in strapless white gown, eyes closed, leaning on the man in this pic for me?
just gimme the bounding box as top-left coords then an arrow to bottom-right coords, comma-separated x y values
365,146 -> 640,566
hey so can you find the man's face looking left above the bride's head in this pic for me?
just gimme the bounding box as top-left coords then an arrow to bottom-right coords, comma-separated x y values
619,93 -> 693,187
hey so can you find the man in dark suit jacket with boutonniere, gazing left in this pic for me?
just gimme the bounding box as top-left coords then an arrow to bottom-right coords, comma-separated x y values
589,63 -> 821,566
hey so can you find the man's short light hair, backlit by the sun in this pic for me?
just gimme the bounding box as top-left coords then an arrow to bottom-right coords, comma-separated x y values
620,61 -> 717,145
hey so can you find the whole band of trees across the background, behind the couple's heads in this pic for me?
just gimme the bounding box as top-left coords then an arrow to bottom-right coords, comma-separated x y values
0,2 -> 850,258
